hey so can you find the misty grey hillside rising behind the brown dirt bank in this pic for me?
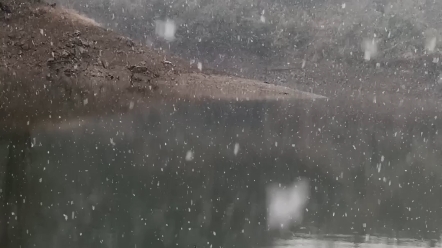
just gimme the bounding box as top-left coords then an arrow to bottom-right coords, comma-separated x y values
59,0 -> 442,95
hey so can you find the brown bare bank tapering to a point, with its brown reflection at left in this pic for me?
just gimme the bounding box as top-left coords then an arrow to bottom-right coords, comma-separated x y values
0,4 -> 320,131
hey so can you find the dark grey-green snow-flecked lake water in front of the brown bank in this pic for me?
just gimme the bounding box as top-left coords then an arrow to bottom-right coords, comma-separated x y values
0,99 -> 442,247
